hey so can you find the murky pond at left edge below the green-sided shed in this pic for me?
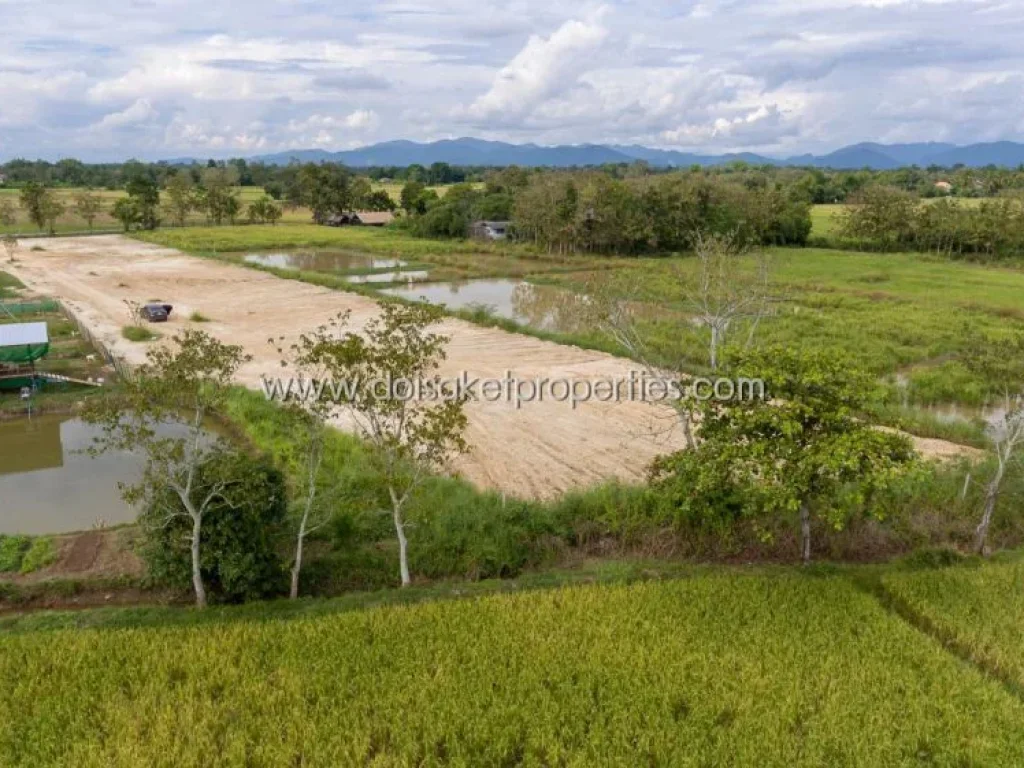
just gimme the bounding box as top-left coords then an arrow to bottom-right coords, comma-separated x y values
0,415 -> 216,535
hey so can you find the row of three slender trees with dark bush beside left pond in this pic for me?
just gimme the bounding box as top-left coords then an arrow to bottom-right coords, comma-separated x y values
85,304 -> 466,607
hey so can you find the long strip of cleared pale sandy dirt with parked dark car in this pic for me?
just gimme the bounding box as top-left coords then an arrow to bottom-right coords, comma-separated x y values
4,236 -> 962,498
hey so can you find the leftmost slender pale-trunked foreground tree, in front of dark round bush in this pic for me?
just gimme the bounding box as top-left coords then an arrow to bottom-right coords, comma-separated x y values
85,329 -> 250,608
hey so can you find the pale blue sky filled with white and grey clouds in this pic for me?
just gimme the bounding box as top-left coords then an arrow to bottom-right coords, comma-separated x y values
0,0 -> 1024,162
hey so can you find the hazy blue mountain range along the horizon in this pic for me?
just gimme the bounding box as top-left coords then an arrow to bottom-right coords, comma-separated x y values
237,138 -> 1024,170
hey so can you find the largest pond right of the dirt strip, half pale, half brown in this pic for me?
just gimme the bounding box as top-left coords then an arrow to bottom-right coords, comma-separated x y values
381,280 -> 587,333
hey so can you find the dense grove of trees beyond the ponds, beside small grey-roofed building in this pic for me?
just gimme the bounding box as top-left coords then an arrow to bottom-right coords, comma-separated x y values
401,168 -> 811,254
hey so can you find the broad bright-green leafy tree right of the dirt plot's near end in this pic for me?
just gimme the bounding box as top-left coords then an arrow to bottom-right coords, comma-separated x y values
651,347 -> 915,563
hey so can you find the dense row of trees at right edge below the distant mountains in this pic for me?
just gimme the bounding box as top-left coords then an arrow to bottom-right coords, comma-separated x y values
841,186 -> 1024,258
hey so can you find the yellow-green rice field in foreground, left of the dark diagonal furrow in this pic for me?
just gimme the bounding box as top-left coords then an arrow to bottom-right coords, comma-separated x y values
0,571 -> 1024,768
